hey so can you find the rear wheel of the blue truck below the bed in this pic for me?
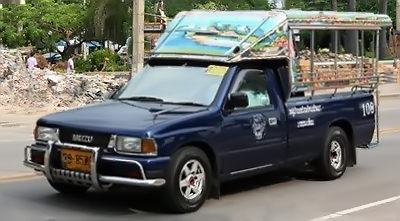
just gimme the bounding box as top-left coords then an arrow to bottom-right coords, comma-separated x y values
316,127 -> 351,180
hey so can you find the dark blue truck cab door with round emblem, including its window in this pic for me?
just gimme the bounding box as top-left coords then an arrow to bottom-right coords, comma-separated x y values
220,69 -> 286,174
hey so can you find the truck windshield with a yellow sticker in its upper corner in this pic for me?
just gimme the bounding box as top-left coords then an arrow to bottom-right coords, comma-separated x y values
115,65 -> 228,106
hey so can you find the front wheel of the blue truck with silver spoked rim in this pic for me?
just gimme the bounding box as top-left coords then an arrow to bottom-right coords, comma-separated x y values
163,146 -> 213,213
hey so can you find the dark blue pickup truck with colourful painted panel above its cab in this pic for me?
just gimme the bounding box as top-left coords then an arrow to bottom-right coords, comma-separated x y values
24,11 -> 386,213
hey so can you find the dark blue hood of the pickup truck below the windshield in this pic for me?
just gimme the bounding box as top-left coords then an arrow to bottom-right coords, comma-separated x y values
38,100 -> 205,136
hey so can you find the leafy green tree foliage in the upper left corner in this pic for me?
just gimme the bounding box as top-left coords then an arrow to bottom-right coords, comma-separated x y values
0,0 -> 86,56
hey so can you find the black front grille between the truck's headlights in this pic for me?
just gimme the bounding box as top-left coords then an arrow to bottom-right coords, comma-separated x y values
59,128 -> 111,148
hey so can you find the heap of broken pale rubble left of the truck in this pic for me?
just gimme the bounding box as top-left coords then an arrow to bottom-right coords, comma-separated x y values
0,48 -> 126,112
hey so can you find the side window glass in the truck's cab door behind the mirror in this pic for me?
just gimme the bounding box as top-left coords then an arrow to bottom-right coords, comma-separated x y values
230,69 -> 271,110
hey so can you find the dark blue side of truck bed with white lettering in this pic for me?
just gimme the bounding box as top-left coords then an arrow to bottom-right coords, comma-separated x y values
286,91 -> 375,159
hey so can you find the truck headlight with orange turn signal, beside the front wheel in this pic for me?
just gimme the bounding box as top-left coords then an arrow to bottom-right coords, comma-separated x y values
115,136 -> 157,155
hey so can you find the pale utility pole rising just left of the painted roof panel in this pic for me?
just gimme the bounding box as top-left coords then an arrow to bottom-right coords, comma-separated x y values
130,0 -> 145,78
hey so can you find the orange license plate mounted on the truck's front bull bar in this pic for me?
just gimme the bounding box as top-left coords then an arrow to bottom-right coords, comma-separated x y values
61,148 -> 92,173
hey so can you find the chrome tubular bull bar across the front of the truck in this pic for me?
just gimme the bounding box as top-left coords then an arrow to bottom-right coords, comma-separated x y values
23,142 -> 165,190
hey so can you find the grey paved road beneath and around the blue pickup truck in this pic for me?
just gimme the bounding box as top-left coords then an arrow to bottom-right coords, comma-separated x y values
0,97 -> 400,221
